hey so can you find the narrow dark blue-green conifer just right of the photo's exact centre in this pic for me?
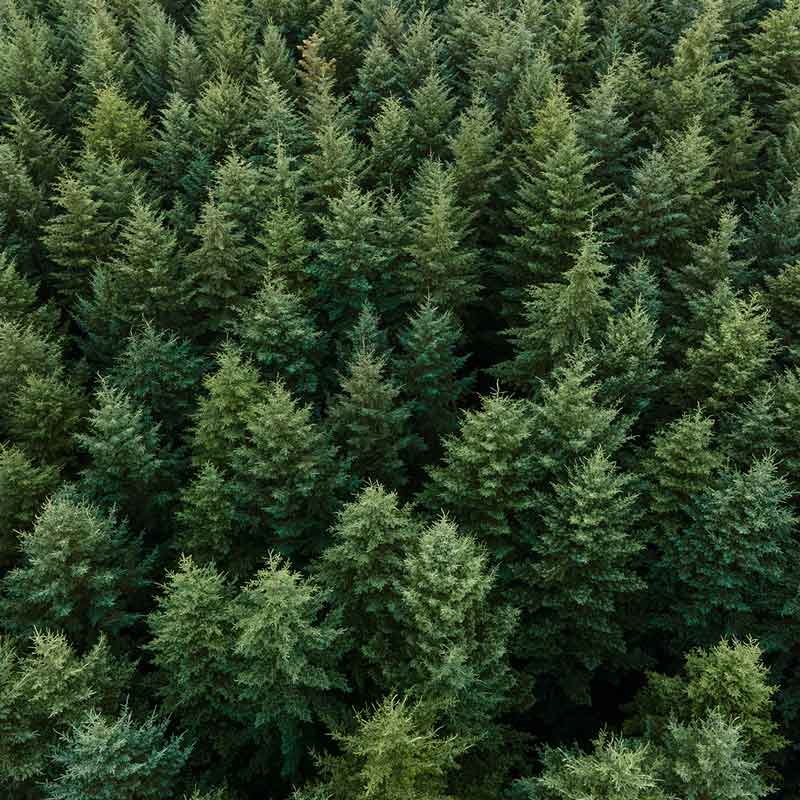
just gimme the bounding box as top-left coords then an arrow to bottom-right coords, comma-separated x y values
396,298 -> 472,454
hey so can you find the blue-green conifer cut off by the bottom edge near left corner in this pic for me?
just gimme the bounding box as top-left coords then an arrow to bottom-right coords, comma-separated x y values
44,708 -> 191,800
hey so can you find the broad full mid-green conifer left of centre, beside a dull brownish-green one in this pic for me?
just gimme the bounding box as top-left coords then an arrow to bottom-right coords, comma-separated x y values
231,381 -> 345,561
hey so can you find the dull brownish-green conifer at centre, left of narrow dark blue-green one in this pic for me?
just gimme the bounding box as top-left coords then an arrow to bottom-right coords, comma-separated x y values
329,350 -> 412,488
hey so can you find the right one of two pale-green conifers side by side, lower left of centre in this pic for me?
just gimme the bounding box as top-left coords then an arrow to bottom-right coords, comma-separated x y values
234,554 -> 347,776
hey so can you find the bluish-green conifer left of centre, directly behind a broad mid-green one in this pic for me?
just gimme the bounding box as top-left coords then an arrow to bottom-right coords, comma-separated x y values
233,279 -> 321,398
